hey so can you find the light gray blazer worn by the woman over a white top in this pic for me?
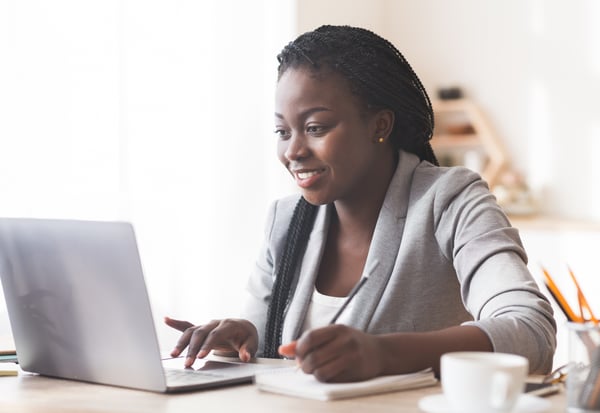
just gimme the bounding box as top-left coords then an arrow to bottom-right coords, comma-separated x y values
242,152 -> 556,373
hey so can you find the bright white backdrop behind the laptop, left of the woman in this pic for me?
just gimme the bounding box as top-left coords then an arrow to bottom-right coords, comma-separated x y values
0,0 -> 294,348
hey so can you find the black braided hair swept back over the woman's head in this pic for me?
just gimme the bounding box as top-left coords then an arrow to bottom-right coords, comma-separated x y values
277,26 -> 439,165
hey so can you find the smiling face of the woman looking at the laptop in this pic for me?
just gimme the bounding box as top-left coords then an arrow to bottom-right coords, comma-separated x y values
275,68 -> 393,205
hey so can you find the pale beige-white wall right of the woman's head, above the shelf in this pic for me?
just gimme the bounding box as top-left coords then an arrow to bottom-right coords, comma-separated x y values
298,0 -> 600,221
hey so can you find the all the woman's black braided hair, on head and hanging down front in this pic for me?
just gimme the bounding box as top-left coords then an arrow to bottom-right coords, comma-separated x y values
263,26 -> 438,358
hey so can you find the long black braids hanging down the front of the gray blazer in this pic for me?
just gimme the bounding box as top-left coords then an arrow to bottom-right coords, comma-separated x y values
264,197 -> 318,358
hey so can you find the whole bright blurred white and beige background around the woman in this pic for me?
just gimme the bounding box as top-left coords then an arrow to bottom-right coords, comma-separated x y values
0,0 -> 600,366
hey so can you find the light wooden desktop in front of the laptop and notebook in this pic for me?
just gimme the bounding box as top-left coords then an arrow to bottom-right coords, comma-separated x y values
0,366 -> 565,413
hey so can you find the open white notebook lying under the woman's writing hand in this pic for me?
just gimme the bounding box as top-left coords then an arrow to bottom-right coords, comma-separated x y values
254,369 -> 437,400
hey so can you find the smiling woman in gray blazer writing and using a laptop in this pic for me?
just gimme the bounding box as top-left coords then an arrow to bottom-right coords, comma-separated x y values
166,26 -> 556,381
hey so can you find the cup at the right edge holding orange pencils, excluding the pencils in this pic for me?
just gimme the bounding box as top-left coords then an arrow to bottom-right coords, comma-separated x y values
567,323 -> 600,413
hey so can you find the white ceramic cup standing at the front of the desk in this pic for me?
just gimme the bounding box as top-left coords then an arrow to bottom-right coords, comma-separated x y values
440,351 -> 529,413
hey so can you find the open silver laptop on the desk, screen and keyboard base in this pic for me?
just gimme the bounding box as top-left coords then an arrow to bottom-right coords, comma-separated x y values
0,218 -> 273,392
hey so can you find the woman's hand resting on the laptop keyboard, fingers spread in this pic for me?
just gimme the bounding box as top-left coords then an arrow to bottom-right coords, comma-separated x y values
165,317 -> 258,367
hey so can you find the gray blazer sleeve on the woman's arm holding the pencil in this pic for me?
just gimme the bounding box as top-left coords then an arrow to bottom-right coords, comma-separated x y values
435,169 -> 556,373
